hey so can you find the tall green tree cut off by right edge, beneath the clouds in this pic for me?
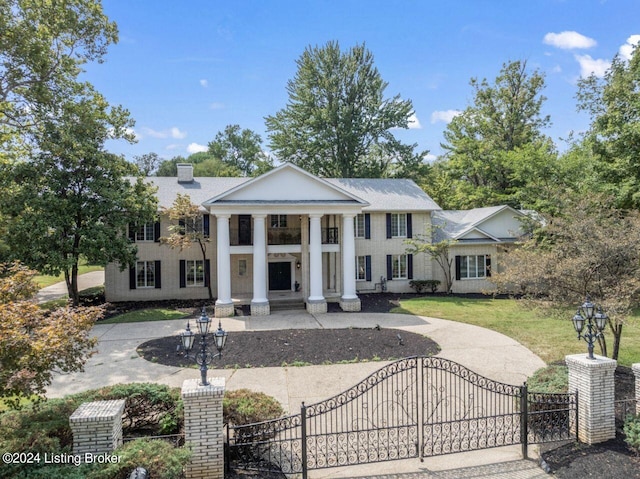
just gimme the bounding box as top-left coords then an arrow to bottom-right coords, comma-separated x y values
577,46 -> 640,209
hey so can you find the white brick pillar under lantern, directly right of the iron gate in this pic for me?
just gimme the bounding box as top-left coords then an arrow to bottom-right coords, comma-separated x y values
565,354 -> 617,444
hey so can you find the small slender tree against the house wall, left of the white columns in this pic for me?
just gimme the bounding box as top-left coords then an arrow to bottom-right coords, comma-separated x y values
160,193 -> 213,299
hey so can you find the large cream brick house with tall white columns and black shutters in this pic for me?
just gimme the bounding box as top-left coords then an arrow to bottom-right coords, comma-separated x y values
105,163 -> 522,317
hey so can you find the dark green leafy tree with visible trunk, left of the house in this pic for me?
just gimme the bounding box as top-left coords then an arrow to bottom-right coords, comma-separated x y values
0,93 -> 157,305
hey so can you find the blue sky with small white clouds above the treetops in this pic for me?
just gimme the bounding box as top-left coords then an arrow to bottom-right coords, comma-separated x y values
84,0 -> 640,165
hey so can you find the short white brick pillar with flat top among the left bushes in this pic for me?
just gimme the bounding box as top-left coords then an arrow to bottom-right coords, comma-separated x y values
69,399 -> 125,454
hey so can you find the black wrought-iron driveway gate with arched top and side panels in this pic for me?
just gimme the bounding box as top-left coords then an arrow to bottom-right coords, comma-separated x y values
226,357 -> 577,477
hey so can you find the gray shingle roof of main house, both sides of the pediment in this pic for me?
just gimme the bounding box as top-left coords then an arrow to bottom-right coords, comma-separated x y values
140,176 -> 440,211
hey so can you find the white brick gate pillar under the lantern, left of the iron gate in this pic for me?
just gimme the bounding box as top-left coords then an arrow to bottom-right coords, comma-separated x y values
182,378 -> 225,479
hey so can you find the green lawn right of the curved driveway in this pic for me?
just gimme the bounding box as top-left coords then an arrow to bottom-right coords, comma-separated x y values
392,296 -> 640,366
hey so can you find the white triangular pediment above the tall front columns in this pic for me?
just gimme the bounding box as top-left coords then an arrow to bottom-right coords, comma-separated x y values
204,163 -> 367,206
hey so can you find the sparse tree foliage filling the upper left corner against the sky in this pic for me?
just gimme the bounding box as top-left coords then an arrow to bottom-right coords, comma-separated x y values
0,0 -> 118,136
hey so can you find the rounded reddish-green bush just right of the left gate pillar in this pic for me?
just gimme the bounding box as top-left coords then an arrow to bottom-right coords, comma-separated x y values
222,389 -> 284,425
